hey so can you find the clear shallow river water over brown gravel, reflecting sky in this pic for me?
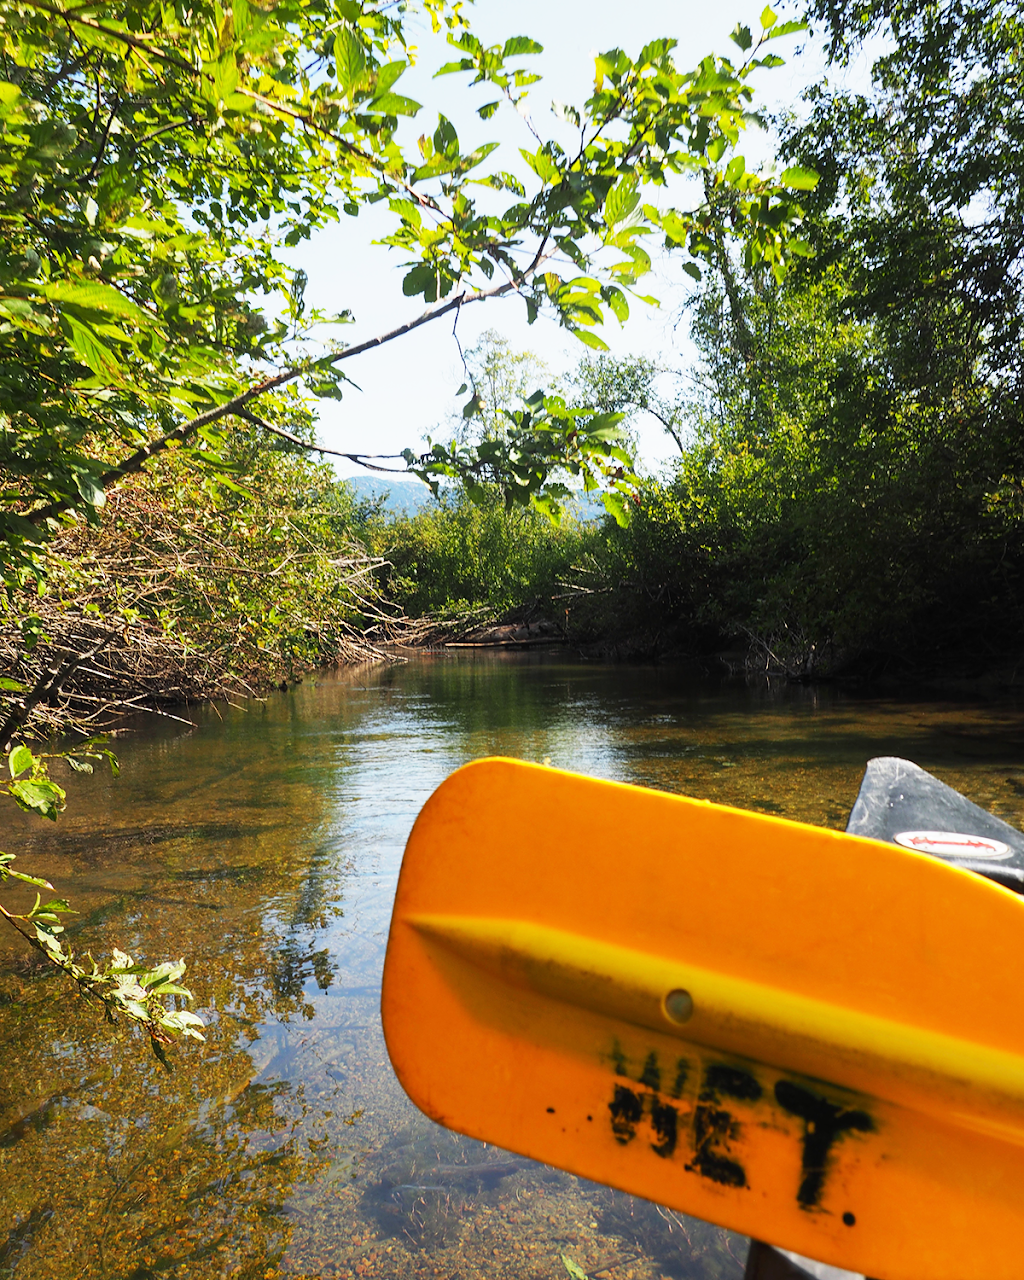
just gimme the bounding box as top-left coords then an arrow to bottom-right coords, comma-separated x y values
0,655 -> 1024,1280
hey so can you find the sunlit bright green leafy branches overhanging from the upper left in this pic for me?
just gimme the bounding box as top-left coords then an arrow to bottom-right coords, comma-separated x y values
0,0 -> 808,590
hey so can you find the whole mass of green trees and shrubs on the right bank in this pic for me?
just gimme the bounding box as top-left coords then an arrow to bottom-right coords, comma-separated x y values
527,0 -> 1024,682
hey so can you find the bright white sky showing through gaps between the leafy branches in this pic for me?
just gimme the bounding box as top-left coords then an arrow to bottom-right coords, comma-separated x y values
284,0 -> 870,475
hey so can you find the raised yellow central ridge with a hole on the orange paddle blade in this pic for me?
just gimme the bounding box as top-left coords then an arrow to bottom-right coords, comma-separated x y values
408,915 -> 1024,1144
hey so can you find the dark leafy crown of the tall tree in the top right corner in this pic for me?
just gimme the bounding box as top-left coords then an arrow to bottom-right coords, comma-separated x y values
785,0 -> 1024,455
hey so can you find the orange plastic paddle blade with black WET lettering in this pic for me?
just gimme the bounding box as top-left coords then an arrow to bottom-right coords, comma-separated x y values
383,759 -> 1024,1280
